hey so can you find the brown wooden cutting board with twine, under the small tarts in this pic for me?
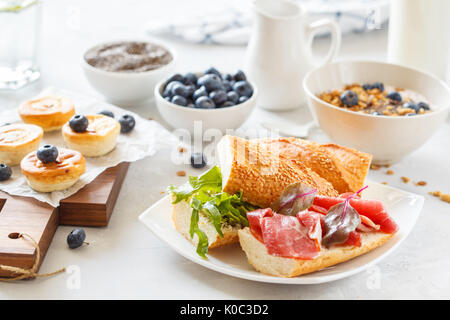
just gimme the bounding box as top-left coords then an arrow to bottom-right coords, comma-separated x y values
0,162 -> 129,277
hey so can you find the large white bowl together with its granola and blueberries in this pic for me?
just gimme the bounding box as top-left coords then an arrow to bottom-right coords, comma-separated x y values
303,61 -> 450,165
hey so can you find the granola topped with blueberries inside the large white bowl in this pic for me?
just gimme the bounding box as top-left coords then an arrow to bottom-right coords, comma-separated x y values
318,82 -> 431,116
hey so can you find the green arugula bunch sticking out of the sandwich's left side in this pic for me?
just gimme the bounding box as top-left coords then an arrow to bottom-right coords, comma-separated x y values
167,166 -> 257,258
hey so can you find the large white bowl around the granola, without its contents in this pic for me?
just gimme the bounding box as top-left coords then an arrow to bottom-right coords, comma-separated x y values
303,61 -> 450,164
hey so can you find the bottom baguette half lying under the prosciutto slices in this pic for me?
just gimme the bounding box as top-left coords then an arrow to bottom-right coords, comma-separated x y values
238,228 -> 393,278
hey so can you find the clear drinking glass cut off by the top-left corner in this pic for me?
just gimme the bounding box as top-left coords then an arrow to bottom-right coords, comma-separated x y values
0,0 -> 41,89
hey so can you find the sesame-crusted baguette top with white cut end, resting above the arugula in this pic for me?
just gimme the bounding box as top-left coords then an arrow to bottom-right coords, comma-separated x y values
217,135 -> 338,208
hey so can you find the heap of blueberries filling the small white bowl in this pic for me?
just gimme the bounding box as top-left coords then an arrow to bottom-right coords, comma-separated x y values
162,67 -> 253,109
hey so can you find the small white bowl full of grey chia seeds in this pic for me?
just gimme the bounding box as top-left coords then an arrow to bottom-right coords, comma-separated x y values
82,40 -> 177,106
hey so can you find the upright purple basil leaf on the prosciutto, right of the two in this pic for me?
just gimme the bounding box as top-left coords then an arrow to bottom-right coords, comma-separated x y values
322,201 -> 361,248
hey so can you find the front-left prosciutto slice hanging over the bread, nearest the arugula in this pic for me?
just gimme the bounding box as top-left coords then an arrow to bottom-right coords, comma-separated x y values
247,208 -> 322,260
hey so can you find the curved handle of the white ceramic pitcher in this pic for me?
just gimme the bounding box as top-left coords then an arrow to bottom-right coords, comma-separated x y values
306,19 -> 341,65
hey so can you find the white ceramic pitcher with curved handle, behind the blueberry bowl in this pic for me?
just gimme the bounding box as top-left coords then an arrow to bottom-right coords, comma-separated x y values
246,0 -> 341,110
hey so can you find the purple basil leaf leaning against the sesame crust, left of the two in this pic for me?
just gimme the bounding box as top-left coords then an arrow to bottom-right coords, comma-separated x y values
270,182 -> 317,216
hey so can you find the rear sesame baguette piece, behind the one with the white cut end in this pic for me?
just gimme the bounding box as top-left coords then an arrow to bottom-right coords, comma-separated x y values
259,138 -> 372,193
